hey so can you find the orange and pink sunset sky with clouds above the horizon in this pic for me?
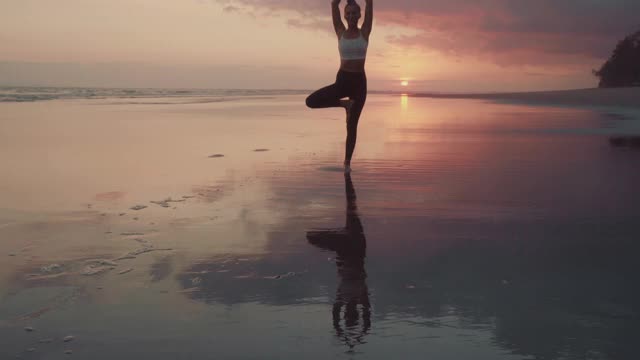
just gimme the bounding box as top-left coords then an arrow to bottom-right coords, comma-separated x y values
0,0 -> 640,92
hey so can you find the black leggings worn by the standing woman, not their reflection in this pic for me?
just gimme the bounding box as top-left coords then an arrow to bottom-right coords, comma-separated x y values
306,70 -> 367,161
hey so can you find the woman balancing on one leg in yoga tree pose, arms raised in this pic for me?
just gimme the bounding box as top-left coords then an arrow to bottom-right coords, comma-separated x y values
307,0 -> 373,173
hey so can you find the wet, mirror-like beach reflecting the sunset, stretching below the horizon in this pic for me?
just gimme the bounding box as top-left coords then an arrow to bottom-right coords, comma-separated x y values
0,89 -> 640,359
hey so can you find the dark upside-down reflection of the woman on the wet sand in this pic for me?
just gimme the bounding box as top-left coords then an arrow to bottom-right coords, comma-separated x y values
307,173 -> 371,349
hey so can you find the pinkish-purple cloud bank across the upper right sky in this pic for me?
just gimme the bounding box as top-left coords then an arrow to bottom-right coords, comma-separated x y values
214,0 -> 640,65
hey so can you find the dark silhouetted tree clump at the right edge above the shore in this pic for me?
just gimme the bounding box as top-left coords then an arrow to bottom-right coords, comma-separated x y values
593,30 -> 640,88
